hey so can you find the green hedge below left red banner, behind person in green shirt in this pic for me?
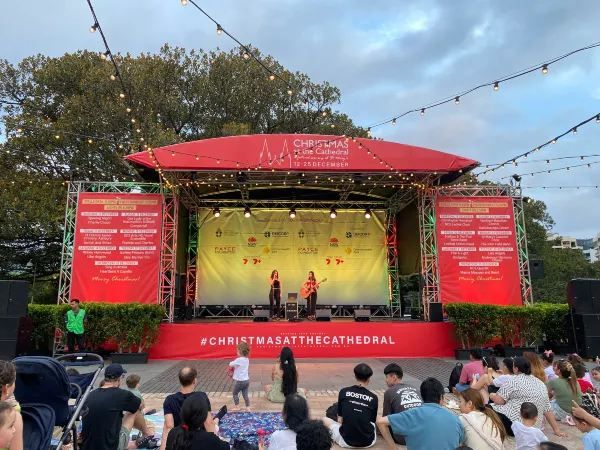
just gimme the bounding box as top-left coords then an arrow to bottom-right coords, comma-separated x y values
28,303 -> 165,352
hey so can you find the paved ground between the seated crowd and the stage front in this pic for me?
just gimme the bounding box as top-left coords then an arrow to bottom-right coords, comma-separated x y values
108,358 -> 583,450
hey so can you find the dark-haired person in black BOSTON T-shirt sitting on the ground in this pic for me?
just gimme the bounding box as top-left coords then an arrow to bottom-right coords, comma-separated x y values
323,363 -> 378,448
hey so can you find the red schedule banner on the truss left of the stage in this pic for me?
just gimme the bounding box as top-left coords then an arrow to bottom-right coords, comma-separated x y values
69,192 -> 163,303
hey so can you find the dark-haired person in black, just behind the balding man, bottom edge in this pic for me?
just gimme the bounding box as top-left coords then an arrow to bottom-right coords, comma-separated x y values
166,395 -> 229,450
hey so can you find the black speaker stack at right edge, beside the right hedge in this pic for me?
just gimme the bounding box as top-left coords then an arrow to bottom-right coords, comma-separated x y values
567,278 -> 600,358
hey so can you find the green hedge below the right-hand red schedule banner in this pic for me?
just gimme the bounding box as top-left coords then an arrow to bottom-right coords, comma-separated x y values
445,303 -> 569,348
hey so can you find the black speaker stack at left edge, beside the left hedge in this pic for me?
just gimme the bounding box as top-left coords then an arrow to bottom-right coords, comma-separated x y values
0,280 -> 29,360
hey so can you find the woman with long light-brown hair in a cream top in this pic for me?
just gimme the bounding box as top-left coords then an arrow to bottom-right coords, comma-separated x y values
458,389 -> 506,450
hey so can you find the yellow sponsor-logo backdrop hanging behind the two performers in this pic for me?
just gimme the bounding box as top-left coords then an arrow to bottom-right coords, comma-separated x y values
196,209 -> 389,305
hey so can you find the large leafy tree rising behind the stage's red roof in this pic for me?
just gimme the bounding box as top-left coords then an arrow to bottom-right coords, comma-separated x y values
0,45 -> 366,284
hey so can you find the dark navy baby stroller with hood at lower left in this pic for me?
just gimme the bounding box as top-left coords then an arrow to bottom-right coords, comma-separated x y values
13,353 -> 104,450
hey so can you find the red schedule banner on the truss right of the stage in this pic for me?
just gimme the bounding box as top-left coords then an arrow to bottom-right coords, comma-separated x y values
436,197 -> 522,305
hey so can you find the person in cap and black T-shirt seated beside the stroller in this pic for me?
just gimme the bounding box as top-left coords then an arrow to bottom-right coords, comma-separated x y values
81,364 -> 158,450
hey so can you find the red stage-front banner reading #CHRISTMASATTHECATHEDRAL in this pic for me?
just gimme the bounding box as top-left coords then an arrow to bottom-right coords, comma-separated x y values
150,319 -> 457,359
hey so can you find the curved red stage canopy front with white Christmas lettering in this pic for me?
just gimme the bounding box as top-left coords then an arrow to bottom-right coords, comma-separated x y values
127,134 -> 478,173
